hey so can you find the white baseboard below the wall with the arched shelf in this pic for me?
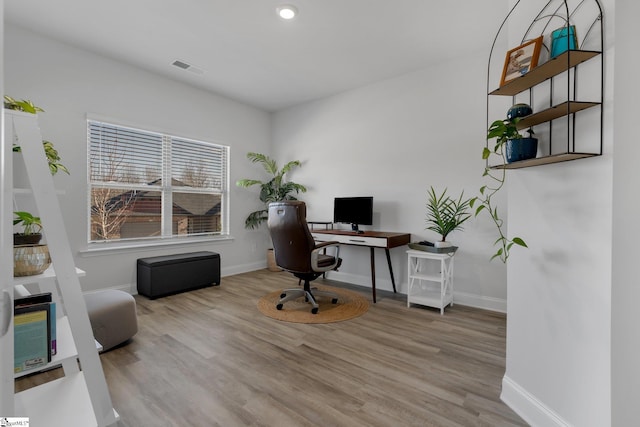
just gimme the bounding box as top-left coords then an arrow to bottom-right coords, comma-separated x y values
500,375 -> 571,427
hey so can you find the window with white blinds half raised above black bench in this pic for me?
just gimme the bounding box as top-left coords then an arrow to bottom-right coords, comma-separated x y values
87,120 -> 229,242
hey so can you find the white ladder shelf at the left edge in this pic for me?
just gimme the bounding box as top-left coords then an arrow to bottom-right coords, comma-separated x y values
0,110 -> 118,427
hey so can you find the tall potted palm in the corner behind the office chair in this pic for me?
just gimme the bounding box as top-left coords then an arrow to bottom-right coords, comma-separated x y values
236,152 -> 307,271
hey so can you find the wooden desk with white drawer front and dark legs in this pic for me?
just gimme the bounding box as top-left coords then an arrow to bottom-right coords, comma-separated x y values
311,230 -> 411,303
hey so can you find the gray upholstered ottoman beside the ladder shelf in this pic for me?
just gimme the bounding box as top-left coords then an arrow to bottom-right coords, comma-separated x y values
84,289 -> 138,351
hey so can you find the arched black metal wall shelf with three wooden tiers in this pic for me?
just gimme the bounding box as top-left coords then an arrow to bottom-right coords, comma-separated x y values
487,0 -> 604,169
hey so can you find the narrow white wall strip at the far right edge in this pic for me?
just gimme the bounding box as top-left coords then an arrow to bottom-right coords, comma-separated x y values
611,0 -> 640,426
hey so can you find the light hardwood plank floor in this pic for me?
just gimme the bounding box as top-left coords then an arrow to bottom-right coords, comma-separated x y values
17,270 -> 526,427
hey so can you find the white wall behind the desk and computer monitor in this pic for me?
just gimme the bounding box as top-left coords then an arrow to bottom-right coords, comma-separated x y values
273,50 -> 506,310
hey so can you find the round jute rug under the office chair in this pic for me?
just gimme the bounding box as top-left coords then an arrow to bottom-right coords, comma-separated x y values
258,286 -> 369,323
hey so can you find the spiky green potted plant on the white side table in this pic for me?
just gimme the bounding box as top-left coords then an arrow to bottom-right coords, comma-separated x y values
426,187 -> 471,248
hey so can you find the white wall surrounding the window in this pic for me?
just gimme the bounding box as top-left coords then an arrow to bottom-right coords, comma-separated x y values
4,25 -> 271,291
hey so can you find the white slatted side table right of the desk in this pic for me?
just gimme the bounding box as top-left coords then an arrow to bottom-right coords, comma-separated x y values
407,248 -> 457,314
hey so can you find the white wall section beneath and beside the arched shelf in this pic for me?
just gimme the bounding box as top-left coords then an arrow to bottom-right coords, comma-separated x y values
502,1 -> 614,426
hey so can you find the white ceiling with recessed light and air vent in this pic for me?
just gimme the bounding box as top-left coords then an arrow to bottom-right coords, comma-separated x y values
4,0 -> 507,111
